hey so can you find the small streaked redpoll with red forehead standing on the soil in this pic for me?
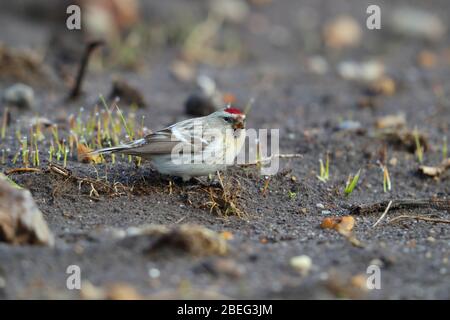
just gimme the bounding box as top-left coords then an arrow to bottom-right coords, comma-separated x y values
92,108 -> 245,181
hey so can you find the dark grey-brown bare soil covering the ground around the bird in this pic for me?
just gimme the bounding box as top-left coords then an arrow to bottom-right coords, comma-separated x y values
0,0 -> 450,299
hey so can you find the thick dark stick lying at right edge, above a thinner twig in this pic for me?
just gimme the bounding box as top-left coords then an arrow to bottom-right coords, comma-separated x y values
350,199 -> 450,214
